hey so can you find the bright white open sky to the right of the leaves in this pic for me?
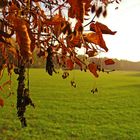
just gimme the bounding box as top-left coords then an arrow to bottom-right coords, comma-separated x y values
100,0 -> 140,62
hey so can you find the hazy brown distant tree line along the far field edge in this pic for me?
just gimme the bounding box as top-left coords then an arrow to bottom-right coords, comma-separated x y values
32,54 -> 140,71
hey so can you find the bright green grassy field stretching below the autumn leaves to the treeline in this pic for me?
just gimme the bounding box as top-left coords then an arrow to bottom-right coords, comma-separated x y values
0,69 -> 140,140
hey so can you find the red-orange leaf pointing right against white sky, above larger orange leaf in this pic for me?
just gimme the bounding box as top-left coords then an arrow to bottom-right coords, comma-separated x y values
90,22 -> 116,35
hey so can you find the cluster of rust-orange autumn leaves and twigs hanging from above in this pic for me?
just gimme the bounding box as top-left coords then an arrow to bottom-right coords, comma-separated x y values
0,0 -> 120,105
